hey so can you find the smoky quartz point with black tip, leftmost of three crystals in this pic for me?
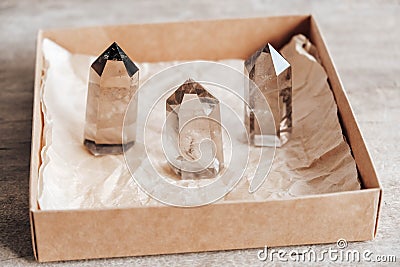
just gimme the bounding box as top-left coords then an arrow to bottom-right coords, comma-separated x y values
84,42 -> 139,156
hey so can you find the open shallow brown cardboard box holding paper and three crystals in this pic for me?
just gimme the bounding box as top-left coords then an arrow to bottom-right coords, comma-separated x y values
30,16 -> 381,262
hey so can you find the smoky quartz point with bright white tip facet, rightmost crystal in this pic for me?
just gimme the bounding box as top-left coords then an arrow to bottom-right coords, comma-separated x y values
245,44 -> 292,147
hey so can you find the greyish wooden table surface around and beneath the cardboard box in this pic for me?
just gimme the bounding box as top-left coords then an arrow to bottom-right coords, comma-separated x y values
0,0 -> 400,266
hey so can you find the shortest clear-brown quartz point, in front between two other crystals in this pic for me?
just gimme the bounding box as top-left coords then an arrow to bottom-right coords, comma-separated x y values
163,79 -> 224,180
